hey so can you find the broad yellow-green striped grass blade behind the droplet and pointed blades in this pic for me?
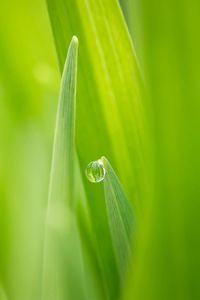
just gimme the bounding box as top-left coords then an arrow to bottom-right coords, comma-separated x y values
47,0 -> 145,299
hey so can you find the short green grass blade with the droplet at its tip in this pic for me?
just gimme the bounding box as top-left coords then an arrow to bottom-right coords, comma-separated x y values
102,157 -> 135,280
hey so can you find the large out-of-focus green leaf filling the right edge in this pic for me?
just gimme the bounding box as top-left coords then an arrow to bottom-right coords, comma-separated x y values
126,0 -> 200,300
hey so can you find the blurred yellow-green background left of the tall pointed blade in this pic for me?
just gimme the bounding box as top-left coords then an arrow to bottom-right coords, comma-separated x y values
0,0 -> 60,300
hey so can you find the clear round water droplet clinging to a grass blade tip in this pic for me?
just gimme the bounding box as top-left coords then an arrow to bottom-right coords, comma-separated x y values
85,159 -> 106,182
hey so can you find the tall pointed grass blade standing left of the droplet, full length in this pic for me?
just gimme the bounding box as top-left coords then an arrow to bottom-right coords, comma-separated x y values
42,37 -> 84,300
